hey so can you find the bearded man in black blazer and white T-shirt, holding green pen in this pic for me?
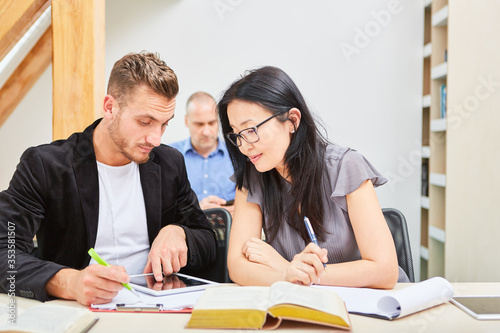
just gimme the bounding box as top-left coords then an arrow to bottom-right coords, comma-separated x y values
0,52 -> 216,305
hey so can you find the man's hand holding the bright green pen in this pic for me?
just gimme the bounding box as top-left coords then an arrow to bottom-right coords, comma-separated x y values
45,264 -> 130,305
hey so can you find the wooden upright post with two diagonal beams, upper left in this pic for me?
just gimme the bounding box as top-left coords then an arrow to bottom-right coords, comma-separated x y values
0,0 -> 105,139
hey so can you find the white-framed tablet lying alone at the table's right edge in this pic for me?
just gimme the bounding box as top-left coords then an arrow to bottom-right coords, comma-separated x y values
451,296 -> 500,320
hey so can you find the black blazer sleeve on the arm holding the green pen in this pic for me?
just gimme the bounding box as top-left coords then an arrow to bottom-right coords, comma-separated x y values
0,148 -> 65,301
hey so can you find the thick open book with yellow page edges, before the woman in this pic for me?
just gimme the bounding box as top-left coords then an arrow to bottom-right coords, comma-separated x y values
186,281 -> 351,330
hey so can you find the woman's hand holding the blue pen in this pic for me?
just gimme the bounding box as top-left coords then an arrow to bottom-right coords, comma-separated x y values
285,243 -> 328,285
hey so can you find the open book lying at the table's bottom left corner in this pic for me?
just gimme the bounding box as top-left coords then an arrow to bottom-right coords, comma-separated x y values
0,302 -> 98,333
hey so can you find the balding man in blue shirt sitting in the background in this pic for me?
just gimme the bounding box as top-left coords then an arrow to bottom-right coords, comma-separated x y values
170,91 -> 235,214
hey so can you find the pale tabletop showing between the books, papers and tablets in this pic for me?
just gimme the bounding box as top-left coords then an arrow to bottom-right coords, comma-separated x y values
0,283 -> 500,333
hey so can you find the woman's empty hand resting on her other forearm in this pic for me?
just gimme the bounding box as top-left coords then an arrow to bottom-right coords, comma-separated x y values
242,237 -> 290,272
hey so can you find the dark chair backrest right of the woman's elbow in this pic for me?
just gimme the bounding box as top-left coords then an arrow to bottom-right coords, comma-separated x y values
382,208 -> 415,282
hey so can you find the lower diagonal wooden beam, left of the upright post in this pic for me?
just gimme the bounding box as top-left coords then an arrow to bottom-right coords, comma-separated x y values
0,27 -> 52,126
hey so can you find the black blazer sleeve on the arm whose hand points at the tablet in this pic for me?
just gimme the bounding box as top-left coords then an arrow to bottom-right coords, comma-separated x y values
170,152 -> 217,271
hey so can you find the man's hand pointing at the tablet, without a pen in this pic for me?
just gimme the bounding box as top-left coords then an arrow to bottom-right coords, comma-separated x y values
143,225 -> 188,281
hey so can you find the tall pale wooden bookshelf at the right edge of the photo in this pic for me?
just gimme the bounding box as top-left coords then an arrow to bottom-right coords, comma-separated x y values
420,0 -> 500,282
